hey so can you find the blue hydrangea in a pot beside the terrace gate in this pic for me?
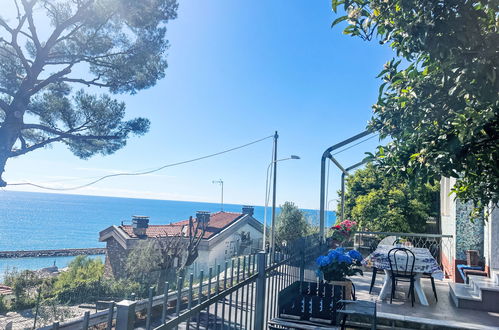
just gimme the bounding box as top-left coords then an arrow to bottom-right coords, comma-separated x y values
316,247 -> 363,300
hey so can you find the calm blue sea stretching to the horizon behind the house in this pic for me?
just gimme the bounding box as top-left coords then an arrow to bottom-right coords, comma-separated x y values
0,190 -> 336,282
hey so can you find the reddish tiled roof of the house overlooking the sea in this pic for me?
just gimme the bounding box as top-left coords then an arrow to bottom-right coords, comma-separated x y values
120,212 -> 243,239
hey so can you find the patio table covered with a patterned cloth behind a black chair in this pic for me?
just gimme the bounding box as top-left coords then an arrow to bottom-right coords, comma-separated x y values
362,245 -> 444,306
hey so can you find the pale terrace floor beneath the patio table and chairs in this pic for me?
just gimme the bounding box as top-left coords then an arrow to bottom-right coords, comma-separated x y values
352,272 -> 499,329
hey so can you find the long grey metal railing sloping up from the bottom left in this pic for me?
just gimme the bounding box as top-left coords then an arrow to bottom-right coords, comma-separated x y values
37,236 -> 326,330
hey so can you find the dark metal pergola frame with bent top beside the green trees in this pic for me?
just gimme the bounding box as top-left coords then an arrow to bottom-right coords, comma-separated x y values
319,131 -> 372,241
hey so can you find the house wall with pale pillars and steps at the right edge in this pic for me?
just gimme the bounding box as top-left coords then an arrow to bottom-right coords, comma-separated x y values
440,178 -> 499,312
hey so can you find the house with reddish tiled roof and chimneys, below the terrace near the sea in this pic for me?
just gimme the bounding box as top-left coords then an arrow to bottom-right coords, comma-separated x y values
99,206 -> 263,278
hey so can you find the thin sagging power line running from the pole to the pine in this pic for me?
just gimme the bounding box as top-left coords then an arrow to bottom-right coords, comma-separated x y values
8,135 -> 274,191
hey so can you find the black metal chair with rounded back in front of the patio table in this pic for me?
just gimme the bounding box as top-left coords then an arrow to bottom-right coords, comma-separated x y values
388,247 -> 416,306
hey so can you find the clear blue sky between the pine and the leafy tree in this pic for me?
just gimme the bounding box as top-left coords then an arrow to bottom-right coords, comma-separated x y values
5,0 -> 394,208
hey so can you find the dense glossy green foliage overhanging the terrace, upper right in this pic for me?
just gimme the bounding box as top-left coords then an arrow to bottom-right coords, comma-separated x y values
332,0 -> 499,209
